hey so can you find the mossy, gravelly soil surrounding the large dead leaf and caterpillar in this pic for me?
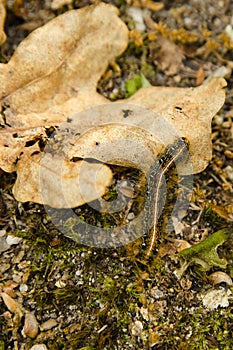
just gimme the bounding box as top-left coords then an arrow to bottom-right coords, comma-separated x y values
0,0 -> 233,350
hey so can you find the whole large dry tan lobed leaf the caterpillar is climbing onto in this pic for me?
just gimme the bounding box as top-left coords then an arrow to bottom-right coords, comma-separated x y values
0,3 -> 225,208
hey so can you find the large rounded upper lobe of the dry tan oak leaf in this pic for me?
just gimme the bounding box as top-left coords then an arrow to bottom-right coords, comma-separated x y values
0,3 -> 128,113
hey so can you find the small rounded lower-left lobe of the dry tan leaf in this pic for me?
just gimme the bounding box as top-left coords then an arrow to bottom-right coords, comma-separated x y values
13,154 -> 112,208
